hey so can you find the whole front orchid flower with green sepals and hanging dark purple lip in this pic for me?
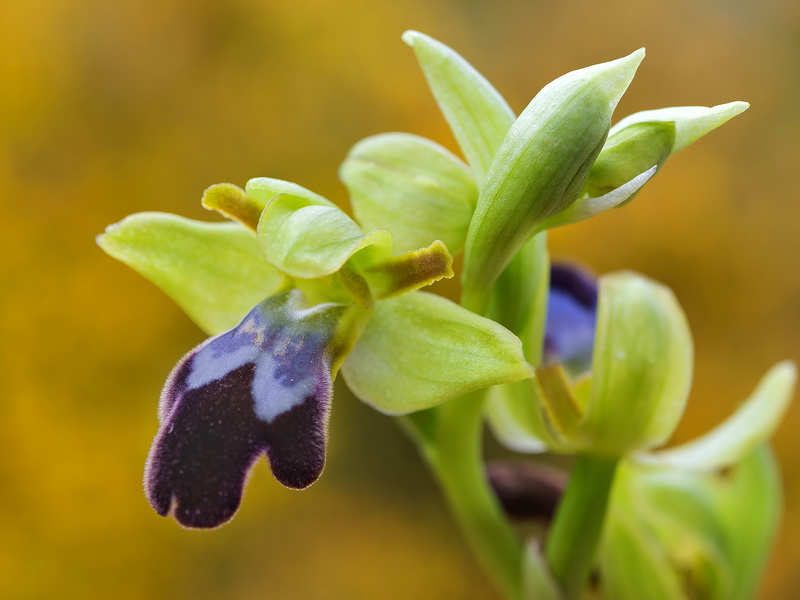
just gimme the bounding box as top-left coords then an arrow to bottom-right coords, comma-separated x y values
98,178 -> 530,528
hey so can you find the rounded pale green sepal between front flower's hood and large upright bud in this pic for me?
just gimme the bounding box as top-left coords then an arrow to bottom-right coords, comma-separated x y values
339,133 -> 478,253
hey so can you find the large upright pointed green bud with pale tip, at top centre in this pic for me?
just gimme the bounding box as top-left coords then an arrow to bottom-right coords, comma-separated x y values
462,50 -> 644,312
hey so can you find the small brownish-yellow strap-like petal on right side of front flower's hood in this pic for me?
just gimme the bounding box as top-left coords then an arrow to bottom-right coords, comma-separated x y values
364,240 -> 454,300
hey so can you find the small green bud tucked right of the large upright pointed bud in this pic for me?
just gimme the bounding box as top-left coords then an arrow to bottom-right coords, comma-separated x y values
584,122 -> 675,202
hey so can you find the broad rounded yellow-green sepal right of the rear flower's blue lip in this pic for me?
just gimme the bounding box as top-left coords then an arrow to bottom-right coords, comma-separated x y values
583,273 -> 693,456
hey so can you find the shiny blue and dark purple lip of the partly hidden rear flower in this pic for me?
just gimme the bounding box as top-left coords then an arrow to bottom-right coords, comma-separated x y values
544,264 -> 597,373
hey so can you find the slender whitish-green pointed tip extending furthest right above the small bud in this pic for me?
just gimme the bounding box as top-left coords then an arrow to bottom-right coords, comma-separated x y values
609,102 -> 750,154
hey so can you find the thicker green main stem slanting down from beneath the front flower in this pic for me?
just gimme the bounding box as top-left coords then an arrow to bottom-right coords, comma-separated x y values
404,393 -> 523,600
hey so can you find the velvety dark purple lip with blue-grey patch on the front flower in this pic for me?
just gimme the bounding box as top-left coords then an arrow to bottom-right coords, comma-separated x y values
145,291 -> 345,528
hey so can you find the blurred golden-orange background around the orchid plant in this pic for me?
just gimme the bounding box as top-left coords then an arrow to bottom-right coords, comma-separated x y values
0,0 -> 800,600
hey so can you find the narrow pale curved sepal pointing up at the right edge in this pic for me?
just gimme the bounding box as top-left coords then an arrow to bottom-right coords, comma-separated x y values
641,362 -> 797,471
